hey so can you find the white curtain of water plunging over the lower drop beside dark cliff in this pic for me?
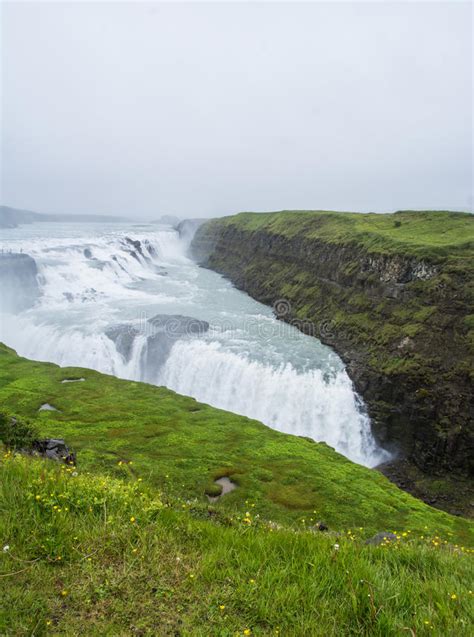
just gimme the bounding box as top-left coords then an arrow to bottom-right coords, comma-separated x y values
156,341 -> 377,463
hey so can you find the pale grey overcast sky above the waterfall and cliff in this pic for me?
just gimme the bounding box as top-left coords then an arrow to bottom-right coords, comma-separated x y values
0,1 -> 473,217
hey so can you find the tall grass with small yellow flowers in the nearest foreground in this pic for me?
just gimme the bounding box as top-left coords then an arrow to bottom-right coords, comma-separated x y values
0,455 -> 473,637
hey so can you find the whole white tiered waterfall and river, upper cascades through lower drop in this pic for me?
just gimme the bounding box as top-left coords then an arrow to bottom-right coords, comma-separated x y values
0,223 -> 388,466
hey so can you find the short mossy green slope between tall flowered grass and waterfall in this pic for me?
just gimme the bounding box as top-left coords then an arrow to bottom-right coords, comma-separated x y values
0,346 -> 472,542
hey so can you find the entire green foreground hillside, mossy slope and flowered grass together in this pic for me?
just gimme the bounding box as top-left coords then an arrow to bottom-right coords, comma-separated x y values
0,345 -> 473,637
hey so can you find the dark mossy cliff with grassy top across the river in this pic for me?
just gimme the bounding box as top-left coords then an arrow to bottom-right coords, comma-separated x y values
191,211 -> 474,486
